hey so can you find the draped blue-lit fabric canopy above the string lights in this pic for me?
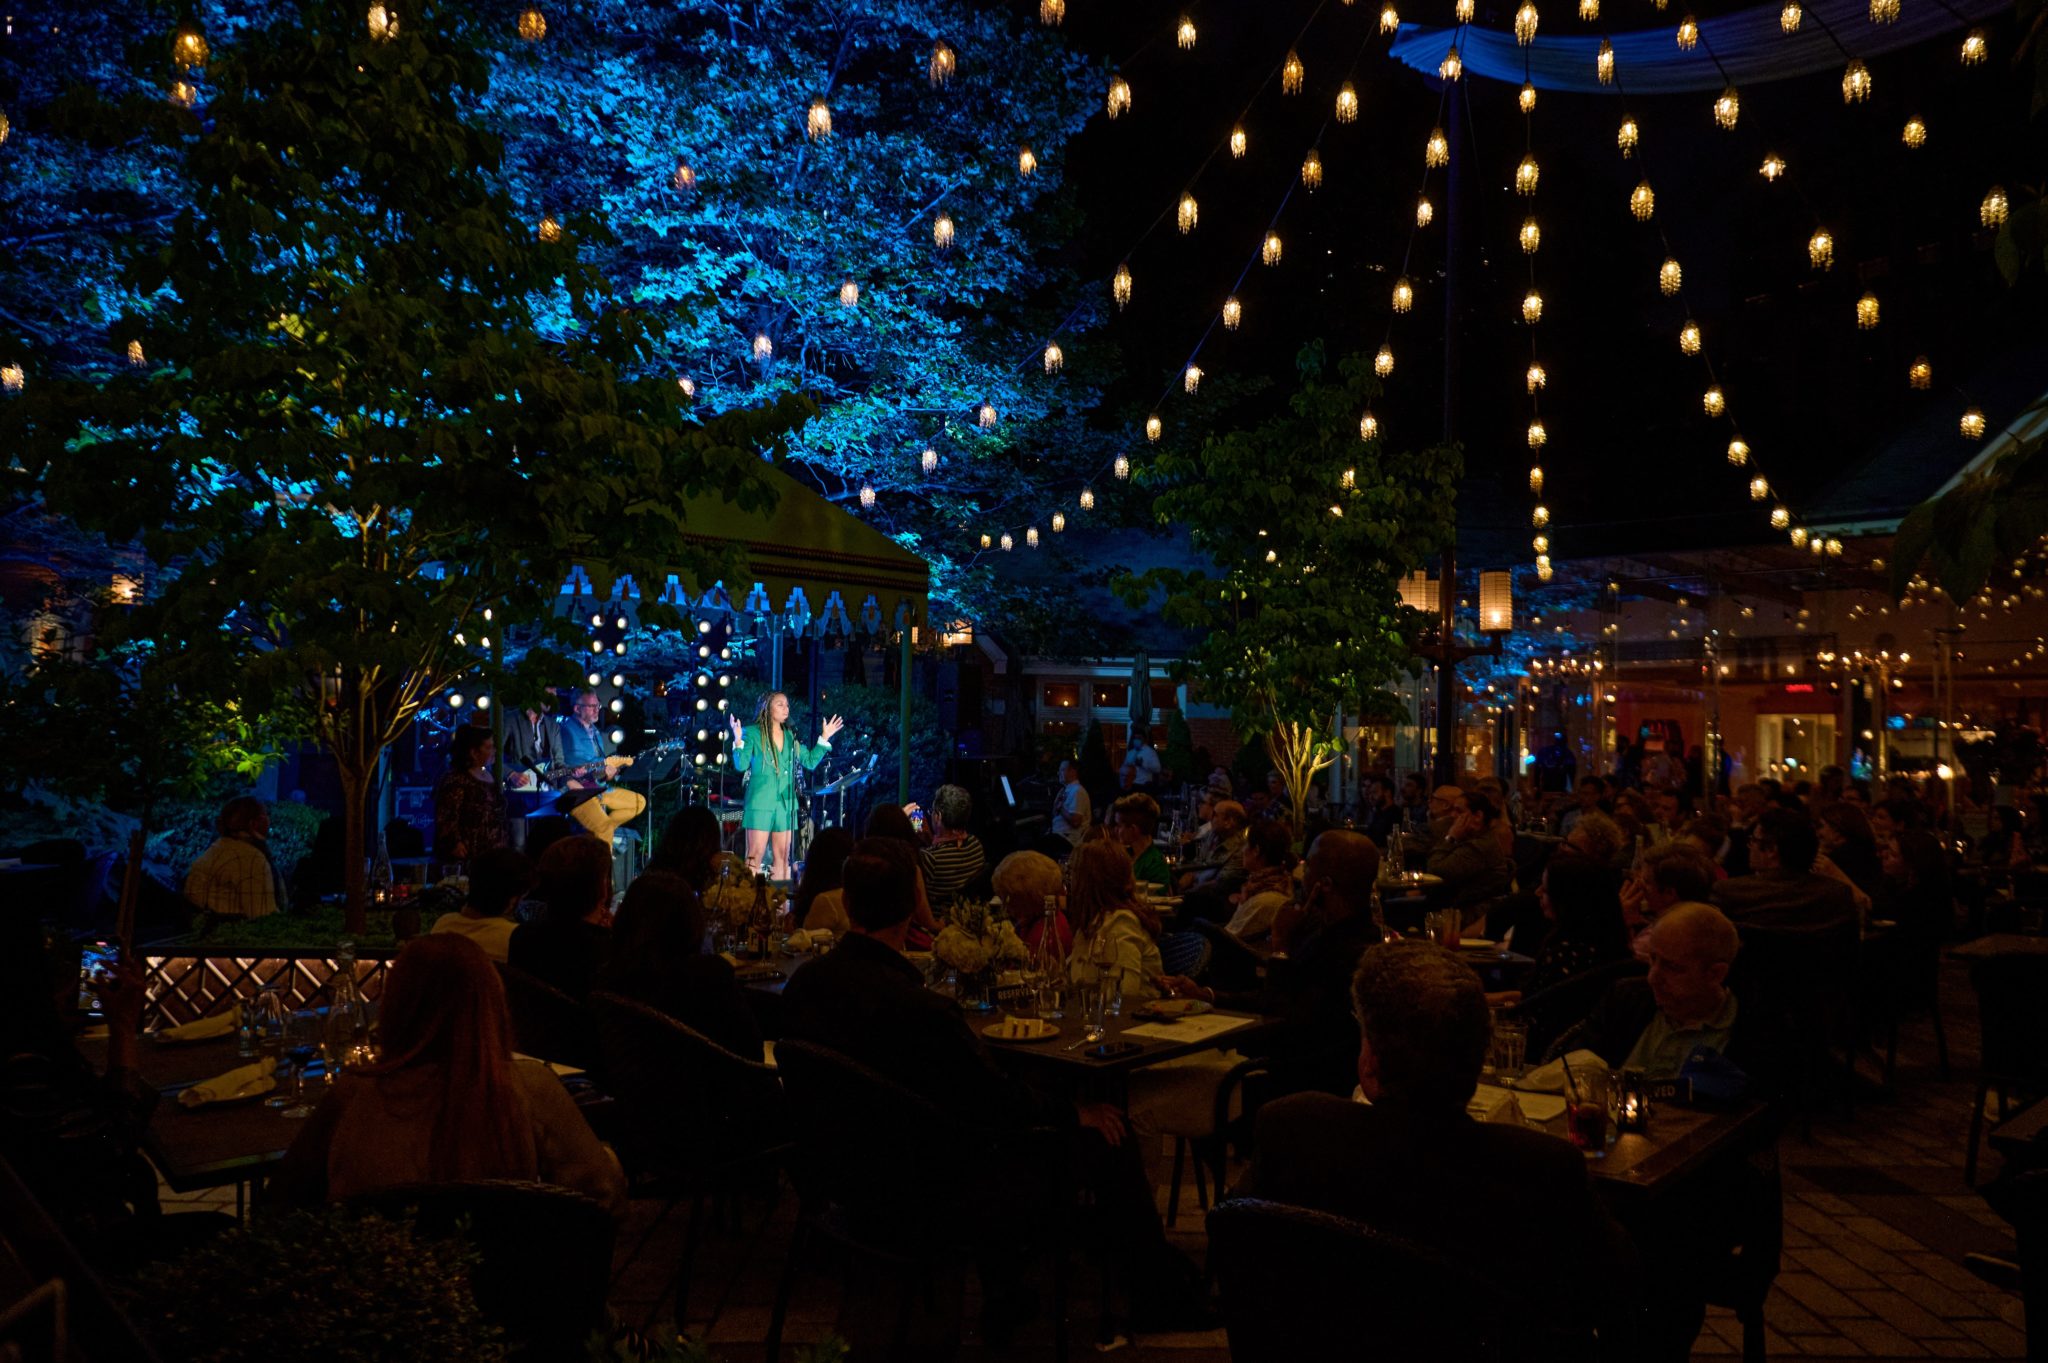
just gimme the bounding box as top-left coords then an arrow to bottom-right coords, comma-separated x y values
1391,0 -> 2013,94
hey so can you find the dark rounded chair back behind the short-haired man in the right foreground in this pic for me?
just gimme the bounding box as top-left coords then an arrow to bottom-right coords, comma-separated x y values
1208,1197 -> 1499,1363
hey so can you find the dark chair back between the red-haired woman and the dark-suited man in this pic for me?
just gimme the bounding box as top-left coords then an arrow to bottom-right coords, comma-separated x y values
590,988 -> 788,1173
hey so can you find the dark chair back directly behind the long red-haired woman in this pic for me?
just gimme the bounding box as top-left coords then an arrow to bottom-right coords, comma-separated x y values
348,1179 -> 614,1361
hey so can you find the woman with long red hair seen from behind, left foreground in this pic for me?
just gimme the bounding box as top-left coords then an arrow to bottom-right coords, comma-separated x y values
266,933 -> 627,1216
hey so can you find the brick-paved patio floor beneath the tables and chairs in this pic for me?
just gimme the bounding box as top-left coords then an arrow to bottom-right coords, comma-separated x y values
166,949 -> 2025,1363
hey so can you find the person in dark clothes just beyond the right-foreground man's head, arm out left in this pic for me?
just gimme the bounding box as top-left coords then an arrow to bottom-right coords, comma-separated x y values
1163,829 -> 1382,1093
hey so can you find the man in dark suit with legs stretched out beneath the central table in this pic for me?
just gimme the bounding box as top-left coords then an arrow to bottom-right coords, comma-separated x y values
782,837 -> 1202,1328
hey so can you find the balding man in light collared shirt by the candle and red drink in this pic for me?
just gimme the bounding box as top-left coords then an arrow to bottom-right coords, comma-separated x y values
1569,905 -> 1769,1081
